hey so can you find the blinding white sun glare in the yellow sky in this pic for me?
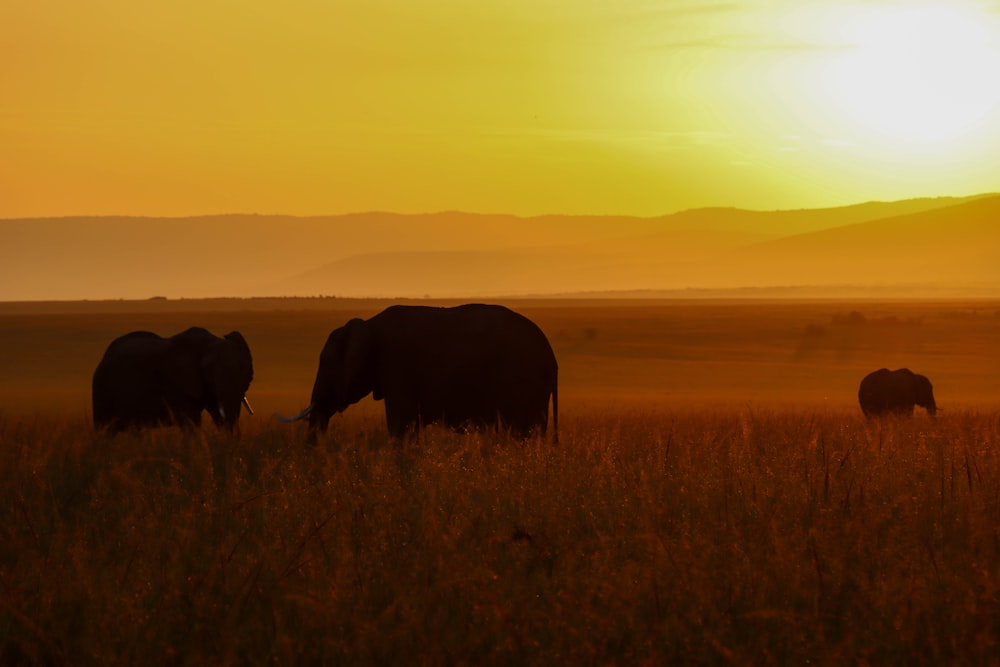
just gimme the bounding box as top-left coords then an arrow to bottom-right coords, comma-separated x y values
830,2 -> 1000,150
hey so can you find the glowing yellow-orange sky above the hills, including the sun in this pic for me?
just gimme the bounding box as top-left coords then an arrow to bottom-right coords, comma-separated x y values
0,0 -> 1000,217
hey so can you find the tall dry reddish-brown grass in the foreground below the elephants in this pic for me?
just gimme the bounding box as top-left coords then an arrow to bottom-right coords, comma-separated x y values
0,408 -> 1000,665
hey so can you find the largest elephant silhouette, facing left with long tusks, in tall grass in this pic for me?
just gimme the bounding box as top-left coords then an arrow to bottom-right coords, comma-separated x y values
284,304 -> 559,440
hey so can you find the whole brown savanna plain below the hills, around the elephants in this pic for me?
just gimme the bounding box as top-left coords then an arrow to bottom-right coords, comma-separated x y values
0,299 -> 1000,665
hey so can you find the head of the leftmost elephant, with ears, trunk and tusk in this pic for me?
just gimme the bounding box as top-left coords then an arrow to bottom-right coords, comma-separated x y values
163,327 -> 253,430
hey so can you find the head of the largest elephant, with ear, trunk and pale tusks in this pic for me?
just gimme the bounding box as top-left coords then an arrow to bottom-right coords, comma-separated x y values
281,318 -> 381,431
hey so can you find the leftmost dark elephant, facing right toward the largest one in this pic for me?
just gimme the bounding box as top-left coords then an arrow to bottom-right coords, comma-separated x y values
93,327 -> 253,433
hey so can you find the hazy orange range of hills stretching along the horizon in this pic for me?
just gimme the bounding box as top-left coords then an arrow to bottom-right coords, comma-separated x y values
0,195 -> 1000,301
